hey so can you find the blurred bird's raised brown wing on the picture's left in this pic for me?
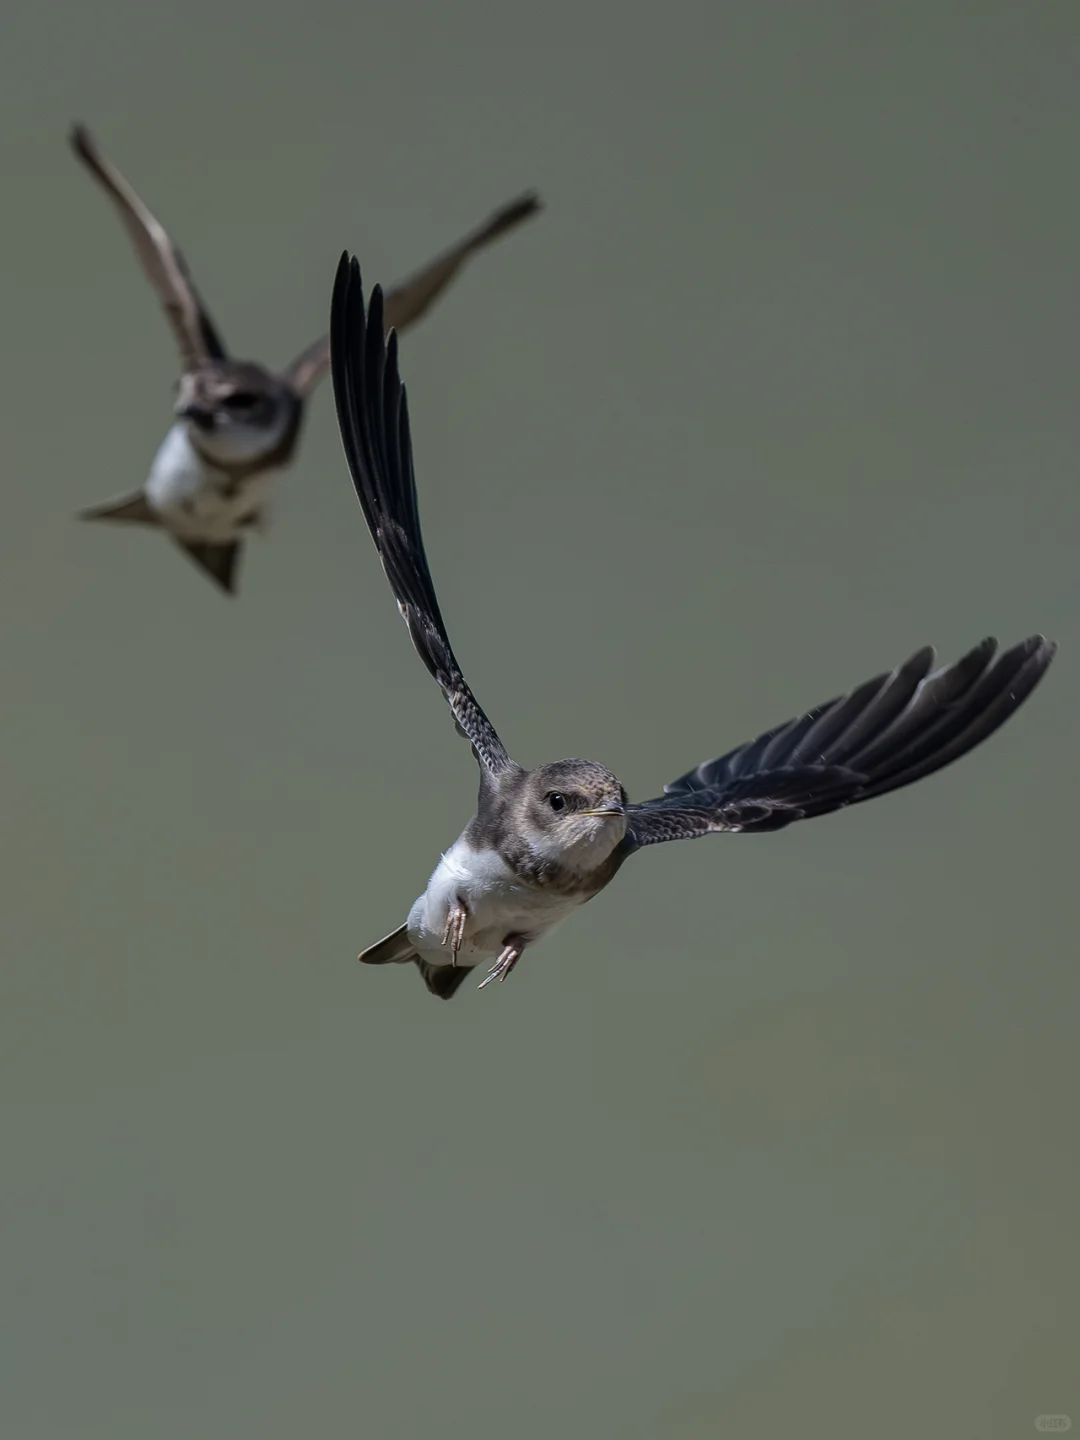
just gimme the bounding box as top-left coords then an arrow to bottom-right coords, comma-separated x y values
71,125 -> 226,367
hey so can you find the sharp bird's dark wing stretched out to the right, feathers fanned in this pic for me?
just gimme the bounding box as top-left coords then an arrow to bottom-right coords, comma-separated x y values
626,635 -> 1057,850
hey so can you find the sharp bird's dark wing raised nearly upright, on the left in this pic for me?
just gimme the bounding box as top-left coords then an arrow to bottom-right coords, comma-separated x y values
330,253 -> 516,776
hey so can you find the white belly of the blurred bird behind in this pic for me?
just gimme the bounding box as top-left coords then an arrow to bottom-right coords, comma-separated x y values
144,423 -> 276,544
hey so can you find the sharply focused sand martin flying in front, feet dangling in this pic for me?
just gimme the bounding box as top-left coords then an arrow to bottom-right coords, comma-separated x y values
330,255 -> 1056,999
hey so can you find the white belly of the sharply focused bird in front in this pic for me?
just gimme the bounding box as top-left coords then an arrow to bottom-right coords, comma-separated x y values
409,840 -> 582,965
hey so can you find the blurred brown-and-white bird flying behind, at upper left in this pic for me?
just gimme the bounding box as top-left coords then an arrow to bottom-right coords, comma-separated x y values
71,125 -> 540,593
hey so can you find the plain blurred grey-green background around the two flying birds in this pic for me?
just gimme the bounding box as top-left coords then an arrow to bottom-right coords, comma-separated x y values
0,0 -> 1080,1440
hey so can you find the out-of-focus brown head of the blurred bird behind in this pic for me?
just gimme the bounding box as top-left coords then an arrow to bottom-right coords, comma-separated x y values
174,360 -> 298,465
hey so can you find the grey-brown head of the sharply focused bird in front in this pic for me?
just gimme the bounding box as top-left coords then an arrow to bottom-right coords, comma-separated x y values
520,760 -> 626,871
